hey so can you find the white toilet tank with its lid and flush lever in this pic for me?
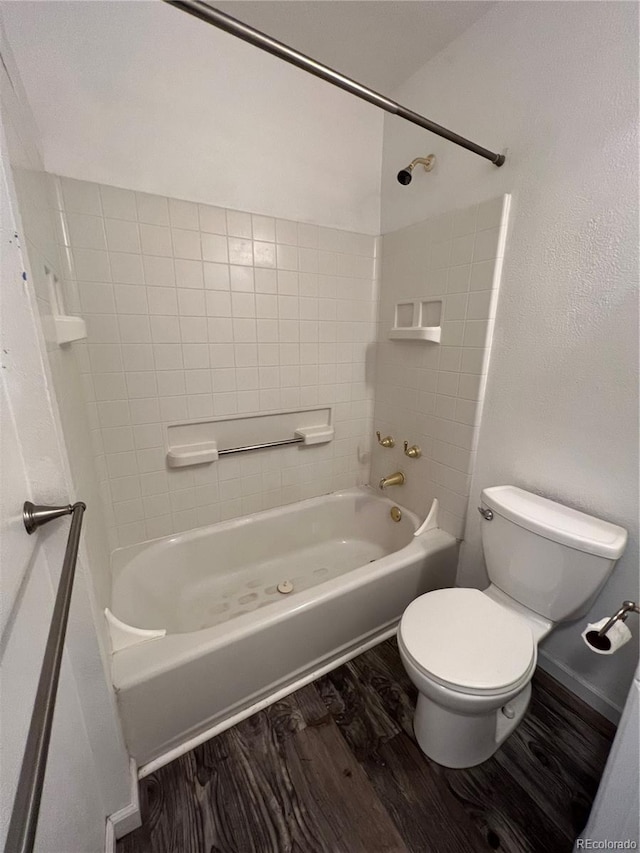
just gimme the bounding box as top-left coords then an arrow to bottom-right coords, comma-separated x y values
482,486 -> 627,622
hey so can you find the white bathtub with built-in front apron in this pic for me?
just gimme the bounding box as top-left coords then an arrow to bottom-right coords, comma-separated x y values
111,487 -> 457,776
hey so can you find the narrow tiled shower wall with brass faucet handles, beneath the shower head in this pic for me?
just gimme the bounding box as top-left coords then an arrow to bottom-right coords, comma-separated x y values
371,196 -> 509,538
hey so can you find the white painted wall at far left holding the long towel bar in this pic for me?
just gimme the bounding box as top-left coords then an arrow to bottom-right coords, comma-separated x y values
0,21 -> 131,853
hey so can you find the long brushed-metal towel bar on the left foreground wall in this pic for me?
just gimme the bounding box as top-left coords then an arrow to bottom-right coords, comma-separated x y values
4,501 -> 87,853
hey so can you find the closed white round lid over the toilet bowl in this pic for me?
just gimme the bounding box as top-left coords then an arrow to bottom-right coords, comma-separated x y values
400,588 -> 536,692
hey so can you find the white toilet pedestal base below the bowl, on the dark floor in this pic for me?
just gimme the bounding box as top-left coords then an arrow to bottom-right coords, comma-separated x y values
413,683 -> 531,768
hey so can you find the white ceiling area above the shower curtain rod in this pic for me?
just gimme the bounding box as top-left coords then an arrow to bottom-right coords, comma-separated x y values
212,0 -> 495,94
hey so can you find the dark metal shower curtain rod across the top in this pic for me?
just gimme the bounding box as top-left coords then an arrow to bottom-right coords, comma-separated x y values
164,0 -> 504,166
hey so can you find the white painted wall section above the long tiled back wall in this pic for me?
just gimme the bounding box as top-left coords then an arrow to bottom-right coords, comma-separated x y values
2,2 -> 382,234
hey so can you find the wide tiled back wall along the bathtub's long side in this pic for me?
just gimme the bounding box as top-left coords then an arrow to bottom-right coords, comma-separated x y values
54,178 -> 377,547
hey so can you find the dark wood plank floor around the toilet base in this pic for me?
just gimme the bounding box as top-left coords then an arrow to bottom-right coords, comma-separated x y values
117,640 -> 614,853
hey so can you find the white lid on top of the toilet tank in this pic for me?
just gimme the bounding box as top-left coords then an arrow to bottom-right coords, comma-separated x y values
482,486 -> 627,560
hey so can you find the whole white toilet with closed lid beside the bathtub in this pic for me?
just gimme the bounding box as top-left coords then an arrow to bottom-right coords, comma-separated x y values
398,486 -> 627,767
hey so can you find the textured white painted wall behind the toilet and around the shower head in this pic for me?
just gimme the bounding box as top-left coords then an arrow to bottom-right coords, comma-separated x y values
383,2 -> 638,716
